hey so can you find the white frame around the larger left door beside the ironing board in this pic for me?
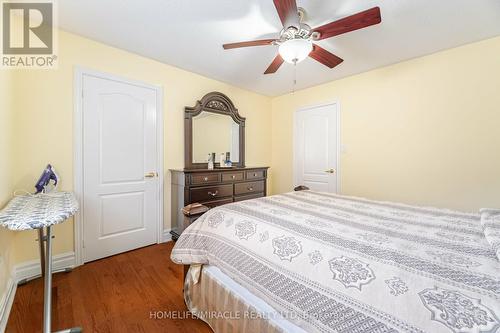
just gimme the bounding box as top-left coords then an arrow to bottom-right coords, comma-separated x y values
73,66 -> 164,266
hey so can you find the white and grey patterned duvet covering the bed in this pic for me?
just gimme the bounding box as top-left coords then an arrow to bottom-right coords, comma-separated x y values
172,191 -> 500,333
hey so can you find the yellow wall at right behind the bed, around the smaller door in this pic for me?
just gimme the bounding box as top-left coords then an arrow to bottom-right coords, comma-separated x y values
271,37 -> 500,210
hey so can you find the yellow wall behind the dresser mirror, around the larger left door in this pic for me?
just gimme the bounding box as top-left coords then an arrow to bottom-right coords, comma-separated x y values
8,31 -> 271,263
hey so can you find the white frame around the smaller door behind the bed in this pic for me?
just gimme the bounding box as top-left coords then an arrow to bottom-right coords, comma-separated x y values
292,101 -> 342,193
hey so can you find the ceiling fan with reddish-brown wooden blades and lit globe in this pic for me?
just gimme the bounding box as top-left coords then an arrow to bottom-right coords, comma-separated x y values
222,0 -> 382,74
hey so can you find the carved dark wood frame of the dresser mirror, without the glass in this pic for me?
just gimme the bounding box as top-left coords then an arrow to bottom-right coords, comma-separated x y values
184,91 -> 245,169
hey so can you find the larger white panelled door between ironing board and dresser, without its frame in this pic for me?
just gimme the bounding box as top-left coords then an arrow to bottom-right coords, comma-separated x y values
82,74 -> 159,262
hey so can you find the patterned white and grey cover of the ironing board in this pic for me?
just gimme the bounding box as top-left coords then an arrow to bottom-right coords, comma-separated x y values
0,192 -> 78,230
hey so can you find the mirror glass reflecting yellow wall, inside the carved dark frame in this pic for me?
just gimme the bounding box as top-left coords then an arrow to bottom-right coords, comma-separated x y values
192,111 -> 240,163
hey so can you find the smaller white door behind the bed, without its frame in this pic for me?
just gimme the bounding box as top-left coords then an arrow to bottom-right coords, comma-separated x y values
294,104 -> 338,193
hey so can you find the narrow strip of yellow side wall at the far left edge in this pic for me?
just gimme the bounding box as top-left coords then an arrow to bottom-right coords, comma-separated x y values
0,70 -> 15,303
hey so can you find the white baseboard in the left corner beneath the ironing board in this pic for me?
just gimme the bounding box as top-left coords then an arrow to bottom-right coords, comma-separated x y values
0,252 -> 75,332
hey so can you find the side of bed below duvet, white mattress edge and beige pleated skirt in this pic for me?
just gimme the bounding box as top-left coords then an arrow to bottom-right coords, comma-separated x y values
184,265 -> 305,333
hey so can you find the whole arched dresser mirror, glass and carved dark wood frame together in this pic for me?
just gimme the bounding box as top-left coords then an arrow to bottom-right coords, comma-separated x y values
184,92 -> 245,169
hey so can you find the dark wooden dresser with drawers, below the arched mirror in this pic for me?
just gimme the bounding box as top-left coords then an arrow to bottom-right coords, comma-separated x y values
170,167 -> 268,240
